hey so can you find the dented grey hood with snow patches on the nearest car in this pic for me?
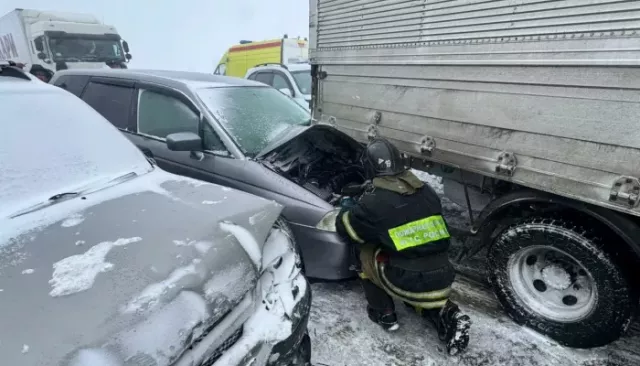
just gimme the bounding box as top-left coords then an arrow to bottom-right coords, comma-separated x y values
0,169 -> 281,366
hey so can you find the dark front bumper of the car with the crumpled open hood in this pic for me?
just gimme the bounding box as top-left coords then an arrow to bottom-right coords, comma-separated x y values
289,223 -> 356,280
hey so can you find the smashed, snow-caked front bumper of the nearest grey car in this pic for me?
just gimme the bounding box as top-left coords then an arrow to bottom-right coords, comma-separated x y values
175,226 -> 311,366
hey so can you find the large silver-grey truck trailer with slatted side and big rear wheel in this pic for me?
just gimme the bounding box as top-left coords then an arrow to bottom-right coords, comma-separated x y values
310,0 -> 640,347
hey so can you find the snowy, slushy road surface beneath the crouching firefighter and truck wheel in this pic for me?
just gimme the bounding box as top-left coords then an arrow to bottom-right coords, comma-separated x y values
309,278 -> 640,366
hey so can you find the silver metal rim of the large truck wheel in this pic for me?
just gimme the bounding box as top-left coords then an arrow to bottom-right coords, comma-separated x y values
508,246 -> 598,323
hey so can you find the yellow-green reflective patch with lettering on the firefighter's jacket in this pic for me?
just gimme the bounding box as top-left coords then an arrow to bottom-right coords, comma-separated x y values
389,215 -> 451,251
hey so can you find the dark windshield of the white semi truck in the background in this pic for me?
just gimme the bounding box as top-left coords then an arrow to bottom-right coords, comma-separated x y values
49,37 -> 125,62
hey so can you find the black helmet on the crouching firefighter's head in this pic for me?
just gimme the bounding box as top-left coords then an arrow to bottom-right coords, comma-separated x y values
362,138 -> 407,179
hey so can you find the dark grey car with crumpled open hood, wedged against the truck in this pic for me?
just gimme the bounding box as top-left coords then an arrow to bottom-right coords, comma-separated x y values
51,70 -> 363,279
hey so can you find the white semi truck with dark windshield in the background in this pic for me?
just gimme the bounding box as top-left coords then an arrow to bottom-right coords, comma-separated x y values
0,9 -> 131,81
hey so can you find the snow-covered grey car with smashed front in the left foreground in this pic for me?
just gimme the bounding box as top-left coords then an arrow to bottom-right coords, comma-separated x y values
0,66 -> 311,366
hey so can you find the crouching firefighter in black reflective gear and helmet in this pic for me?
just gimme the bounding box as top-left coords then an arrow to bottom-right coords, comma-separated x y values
336,139 -> 471,354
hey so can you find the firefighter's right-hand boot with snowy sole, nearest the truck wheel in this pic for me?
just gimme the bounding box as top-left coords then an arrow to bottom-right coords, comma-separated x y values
430,300 -> 471,356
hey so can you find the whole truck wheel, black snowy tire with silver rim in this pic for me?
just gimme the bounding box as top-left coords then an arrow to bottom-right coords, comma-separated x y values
488,218 -> 638,348
